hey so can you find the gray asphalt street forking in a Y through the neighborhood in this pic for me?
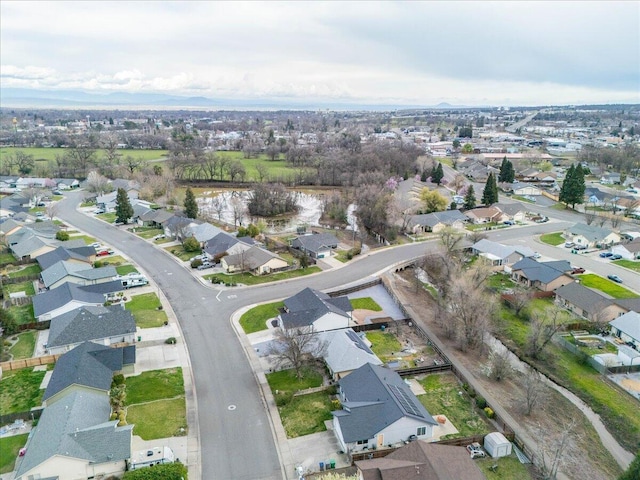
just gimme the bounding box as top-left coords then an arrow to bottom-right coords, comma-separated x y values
57,192 -> 622,480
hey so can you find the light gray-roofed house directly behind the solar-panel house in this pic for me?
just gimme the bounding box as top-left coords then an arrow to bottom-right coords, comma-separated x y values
320,328 -> 382,380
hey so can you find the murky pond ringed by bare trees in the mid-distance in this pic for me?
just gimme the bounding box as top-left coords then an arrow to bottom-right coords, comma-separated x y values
197,190 -> 357,234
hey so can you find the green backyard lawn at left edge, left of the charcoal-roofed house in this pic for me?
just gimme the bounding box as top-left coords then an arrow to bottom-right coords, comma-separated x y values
0,368 -> 46,415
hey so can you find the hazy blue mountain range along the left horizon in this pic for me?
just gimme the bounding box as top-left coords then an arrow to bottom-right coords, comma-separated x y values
0,87 -> 486,110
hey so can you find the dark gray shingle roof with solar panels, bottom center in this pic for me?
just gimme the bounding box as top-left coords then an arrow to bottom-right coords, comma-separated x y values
333,363 -> 437,443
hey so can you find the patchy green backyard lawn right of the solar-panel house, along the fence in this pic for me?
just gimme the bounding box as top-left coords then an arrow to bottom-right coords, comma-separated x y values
418,373 -> 492,438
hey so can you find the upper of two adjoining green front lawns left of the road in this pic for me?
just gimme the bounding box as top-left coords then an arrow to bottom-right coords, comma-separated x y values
126,367 -> 184,405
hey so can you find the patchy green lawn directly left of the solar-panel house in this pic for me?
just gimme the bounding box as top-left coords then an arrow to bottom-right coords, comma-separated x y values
278,392 -> 334,438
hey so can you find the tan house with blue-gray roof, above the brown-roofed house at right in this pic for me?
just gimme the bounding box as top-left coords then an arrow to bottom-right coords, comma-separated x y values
511,258 -> 574,292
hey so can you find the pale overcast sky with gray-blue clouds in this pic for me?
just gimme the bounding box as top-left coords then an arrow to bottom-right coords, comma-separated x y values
0,0 -> 640,105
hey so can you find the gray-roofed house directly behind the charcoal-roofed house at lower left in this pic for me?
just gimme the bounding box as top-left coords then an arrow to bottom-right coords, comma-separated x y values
47,305 -> 136,355
